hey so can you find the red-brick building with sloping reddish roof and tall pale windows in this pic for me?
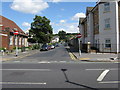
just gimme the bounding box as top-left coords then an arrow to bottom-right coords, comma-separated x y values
0,16 -> 28,50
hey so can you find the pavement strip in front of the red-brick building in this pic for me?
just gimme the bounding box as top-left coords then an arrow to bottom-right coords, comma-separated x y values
0,50 -> 40,61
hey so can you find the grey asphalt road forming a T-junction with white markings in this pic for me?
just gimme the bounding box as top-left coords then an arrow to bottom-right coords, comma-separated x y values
0,45 -> 120,90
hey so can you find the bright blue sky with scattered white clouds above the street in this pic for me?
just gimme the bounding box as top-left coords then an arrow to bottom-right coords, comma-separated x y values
0,0 -> 96,34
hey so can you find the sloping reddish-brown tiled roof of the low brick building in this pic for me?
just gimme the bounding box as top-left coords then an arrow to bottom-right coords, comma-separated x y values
0,16 -> 24,34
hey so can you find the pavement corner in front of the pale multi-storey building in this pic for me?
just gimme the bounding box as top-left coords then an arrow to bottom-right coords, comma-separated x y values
66,46 -> 120,62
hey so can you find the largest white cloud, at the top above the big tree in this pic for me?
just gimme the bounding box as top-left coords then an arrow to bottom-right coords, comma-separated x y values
11,0 -> 49,14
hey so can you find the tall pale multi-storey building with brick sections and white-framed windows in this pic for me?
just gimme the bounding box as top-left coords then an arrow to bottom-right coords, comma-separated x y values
79,0 -> 120,53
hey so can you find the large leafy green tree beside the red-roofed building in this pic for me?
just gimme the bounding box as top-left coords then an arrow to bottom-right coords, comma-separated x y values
29,15 -> 53,43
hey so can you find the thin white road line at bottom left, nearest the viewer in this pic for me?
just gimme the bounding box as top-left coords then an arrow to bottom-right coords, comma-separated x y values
0,82 -> 46,85
